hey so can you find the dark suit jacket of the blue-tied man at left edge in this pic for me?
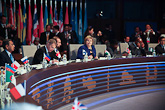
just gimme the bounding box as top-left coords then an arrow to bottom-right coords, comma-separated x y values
0,50 -> 12,66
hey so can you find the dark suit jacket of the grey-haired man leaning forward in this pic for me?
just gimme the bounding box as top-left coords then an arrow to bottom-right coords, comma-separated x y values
33,46 -> 58,64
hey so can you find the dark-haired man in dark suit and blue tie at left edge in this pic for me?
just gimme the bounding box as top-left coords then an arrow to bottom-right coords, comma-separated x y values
0,39 -> 15,66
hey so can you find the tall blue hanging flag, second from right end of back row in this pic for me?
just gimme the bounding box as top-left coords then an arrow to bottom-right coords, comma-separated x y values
79,1 -> 83,44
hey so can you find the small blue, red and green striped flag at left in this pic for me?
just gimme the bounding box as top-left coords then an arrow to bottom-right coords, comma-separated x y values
5,65 -> 16,82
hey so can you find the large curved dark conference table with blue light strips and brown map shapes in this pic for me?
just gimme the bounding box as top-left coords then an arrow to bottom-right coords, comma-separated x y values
12,56 -> 165,110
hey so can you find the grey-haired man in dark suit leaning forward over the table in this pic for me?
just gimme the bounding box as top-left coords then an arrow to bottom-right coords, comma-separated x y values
33,39 -> 58,64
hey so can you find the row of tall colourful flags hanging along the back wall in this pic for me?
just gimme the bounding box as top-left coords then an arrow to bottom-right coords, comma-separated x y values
0,0 -> 87,45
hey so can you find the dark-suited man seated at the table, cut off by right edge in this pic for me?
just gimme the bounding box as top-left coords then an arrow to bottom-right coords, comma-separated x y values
155,37 -> 165,55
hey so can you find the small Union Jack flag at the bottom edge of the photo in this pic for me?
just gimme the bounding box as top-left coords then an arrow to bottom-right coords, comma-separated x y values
72,97 -> 87,110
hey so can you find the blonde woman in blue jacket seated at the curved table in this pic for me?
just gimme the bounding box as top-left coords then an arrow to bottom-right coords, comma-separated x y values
77,35 -> 98,59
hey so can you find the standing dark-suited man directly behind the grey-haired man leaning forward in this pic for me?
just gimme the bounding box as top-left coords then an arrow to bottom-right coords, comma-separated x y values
40,25 -> 54,44
